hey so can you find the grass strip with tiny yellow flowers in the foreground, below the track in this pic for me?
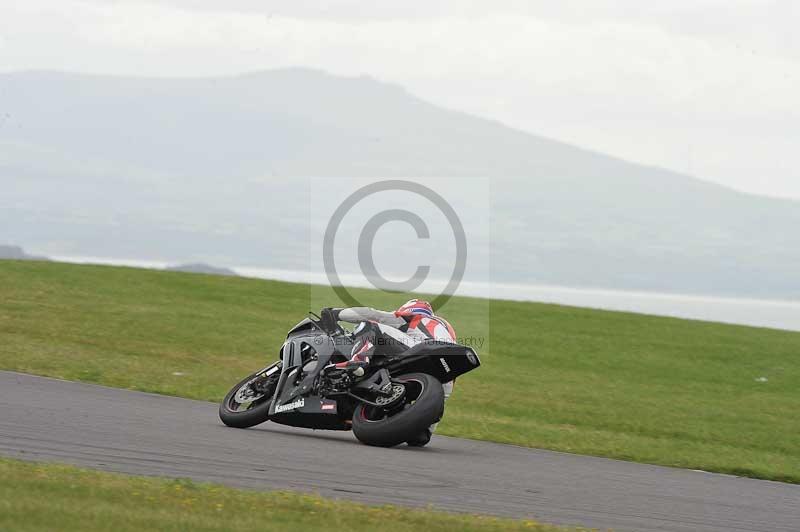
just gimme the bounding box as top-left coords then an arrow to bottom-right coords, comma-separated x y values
0,460 -> 566,532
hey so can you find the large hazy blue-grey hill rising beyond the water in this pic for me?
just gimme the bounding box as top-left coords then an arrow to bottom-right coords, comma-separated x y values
0,69 -> 800,298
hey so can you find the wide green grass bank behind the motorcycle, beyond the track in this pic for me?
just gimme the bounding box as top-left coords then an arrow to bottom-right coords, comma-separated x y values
0,261 -> 800,482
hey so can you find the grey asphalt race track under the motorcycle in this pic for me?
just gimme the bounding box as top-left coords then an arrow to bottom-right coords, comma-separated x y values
0,372 -> 800,532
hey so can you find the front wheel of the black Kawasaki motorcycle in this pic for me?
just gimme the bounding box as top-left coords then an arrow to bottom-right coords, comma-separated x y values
219,366 -> 280,429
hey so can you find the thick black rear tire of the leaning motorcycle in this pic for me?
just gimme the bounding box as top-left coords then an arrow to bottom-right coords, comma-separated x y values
353,373 -> 444,447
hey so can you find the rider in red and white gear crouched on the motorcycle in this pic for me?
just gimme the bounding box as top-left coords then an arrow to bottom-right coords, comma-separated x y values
321,299 -> 456,445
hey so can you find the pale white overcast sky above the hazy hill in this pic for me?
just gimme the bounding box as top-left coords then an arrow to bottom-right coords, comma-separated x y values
0,0 -> 800,198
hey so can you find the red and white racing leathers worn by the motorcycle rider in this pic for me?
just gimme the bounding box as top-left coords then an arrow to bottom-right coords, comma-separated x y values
338,308 -> 456,399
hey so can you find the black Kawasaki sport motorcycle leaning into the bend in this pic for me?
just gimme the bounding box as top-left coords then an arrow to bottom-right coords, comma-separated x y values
219,313 -> 481,447
